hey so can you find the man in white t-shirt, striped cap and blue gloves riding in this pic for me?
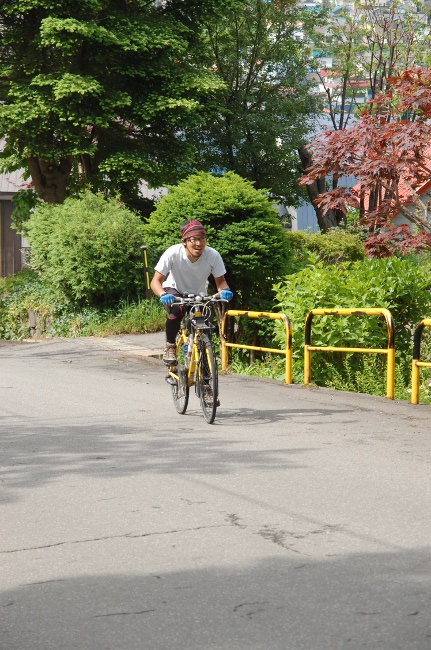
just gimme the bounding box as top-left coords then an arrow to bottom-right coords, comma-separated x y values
150,219 -> 233,365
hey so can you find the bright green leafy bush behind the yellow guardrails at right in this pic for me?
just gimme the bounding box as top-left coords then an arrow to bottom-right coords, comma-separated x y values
274,257 -> 431,385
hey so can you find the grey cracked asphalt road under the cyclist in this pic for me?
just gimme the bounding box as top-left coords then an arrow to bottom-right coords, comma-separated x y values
0,335 -> 431,650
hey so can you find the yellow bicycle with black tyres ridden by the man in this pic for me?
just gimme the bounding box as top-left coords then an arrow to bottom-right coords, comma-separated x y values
166,294 -> 228,424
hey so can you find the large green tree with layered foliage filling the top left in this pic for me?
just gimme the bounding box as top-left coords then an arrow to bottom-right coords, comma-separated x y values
0,0 -> 243,203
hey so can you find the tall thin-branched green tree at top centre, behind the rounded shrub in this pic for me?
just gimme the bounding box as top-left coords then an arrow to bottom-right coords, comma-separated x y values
189,0 -> 320,205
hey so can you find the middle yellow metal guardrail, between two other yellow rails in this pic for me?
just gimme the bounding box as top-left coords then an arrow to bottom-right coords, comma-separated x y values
304,308 -> 394,399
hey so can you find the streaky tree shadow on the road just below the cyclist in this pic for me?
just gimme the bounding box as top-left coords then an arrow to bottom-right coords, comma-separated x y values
0,410 -> 320,502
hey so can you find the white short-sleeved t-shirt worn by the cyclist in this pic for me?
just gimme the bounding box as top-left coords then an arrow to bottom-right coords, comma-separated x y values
155,244 -> 226,296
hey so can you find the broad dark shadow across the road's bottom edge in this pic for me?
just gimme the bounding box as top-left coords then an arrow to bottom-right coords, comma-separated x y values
0,548 -> 431,650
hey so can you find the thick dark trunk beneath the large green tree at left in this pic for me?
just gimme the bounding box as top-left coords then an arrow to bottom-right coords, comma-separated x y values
27,156 -> 73,203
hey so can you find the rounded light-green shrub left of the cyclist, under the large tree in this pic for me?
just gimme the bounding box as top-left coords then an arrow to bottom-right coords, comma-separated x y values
28,192 -> 147,305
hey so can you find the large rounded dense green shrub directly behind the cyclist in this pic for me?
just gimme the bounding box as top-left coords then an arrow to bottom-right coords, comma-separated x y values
144,172 -> 288,309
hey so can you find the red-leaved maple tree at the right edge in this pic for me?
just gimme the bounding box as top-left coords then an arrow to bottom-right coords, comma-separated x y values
301,68 -> 431,257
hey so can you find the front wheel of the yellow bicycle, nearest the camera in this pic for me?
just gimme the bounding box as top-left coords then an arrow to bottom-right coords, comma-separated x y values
197,334 -> 218,424
